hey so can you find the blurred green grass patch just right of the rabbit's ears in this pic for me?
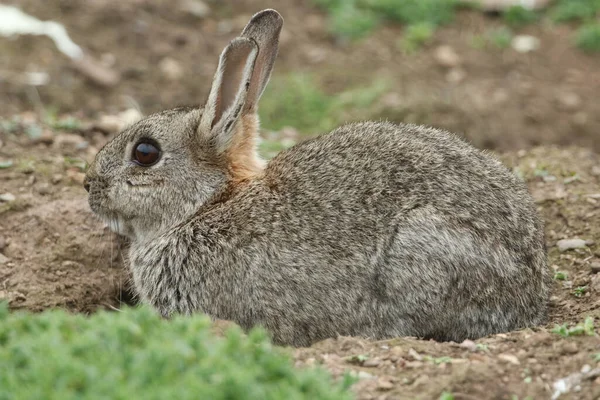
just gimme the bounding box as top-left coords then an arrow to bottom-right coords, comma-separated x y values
259,74 -> 385,134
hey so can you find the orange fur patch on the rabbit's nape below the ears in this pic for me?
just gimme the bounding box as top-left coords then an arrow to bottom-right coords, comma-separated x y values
226,114 -> 264,182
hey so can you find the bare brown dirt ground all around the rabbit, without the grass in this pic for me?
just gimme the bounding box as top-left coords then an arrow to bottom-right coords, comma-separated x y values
0,0 -> 600,400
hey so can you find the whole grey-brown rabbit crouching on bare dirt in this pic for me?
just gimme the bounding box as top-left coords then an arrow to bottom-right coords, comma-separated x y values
84,10 -> 550,347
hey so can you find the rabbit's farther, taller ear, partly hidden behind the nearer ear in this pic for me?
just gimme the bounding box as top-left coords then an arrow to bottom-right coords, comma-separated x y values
242,9 -> 283,112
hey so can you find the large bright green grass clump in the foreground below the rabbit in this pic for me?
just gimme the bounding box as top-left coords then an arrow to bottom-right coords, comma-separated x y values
0,304 -> 352,400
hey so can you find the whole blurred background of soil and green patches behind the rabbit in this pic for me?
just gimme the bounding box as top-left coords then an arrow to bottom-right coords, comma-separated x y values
0,0 -> 600,156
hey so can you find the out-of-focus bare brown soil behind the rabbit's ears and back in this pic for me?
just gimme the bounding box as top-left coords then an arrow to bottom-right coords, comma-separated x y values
0,0 -> 600,150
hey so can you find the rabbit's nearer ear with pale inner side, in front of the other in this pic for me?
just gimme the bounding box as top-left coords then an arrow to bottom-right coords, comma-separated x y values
198,37 -> 258,154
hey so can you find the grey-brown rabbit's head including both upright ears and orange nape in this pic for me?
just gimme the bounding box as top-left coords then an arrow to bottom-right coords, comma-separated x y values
84,10 -> 283,239
